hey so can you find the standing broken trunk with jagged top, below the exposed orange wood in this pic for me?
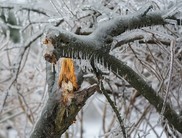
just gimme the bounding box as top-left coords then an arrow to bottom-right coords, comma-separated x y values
30,85 -> 98,138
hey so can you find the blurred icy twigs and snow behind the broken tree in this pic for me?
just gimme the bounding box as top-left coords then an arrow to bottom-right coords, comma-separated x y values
0,0 -> 182,138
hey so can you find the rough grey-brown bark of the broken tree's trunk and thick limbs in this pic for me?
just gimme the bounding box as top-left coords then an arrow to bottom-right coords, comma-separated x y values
31,8 -> 182,138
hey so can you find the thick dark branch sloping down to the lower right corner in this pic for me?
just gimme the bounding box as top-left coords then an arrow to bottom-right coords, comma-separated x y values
98,52 -> 182,133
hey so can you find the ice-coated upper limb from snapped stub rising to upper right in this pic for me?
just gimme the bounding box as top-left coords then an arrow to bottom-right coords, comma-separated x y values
43,9 -> 171,59
